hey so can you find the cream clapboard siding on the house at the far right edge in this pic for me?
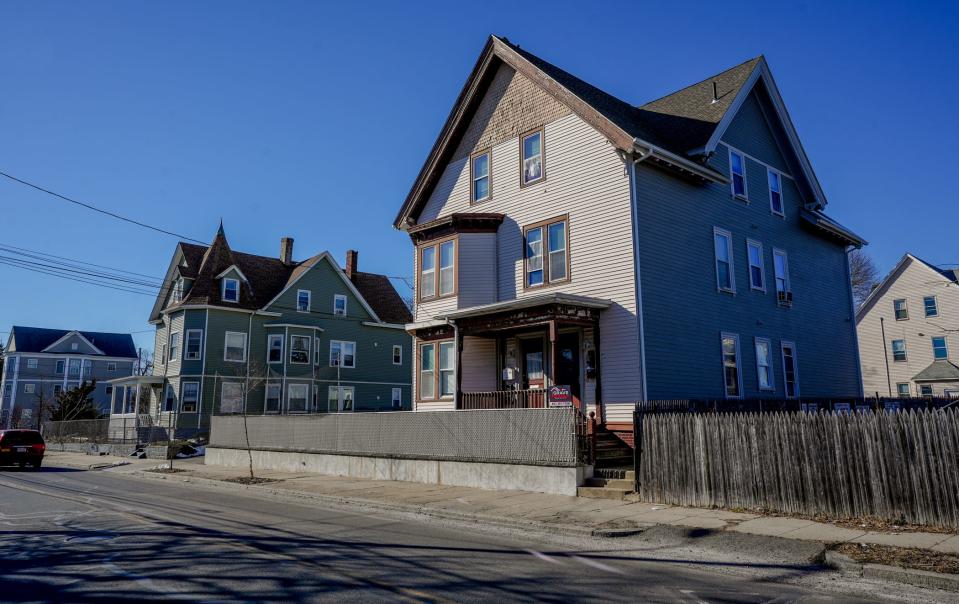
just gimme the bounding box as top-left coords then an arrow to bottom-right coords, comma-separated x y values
858,256 -> 959,396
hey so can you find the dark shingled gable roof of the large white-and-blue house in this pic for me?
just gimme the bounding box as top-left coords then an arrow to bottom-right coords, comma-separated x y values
393,36 -> 826,229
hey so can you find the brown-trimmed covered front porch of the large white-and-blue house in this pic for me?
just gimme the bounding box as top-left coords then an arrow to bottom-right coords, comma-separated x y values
416,292 -> 611,418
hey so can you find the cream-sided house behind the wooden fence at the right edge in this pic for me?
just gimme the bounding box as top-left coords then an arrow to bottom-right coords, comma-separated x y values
856,254 -> 959,397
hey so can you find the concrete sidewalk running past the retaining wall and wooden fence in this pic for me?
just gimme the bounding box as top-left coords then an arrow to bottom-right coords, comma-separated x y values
47,452 -> 959,554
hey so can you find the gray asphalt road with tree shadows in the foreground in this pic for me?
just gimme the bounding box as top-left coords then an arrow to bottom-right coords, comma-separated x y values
0,466 -> 924,604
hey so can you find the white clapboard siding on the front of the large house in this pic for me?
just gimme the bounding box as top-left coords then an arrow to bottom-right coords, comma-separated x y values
416,109 -> 641,421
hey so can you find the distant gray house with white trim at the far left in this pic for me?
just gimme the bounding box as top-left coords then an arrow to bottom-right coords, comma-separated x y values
0,325 -> 137,425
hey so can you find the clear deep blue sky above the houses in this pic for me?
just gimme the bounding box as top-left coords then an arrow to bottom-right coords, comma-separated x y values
0,0 -> 959,347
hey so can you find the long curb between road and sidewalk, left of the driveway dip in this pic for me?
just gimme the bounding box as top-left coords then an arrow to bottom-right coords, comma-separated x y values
129,470 -> 655,539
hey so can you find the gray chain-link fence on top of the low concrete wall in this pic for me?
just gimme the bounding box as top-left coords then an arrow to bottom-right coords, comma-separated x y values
210,408 -> 587,467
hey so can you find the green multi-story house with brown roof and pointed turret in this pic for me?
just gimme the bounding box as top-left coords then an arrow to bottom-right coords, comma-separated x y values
112,225 -> 411,435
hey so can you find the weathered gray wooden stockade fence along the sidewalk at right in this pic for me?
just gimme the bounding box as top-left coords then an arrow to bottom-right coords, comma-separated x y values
637,408 -> 959,528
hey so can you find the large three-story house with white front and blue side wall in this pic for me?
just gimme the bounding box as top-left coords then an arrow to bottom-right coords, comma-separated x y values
394,36 -> 865,430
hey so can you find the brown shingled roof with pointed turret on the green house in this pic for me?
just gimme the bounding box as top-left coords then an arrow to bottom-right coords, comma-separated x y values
151,225 -> 409,323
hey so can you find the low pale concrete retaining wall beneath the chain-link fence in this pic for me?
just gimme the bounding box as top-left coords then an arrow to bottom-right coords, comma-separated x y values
205,447 -> 593,495
